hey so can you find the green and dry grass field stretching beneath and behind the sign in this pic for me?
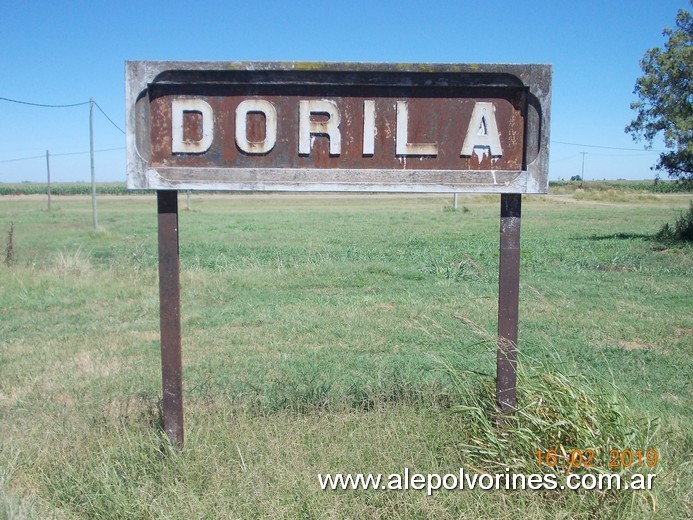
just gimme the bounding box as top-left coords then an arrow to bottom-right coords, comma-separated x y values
0,187 -> 693,519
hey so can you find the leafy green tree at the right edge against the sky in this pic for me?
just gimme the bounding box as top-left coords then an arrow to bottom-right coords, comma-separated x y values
626,0 -> 693,182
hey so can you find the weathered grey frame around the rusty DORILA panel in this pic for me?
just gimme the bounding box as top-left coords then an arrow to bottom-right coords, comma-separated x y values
126,61 -> 551,193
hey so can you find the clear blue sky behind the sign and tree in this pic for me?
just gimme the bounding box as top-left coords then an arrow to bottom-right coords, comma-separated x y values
0,0 -> 691,182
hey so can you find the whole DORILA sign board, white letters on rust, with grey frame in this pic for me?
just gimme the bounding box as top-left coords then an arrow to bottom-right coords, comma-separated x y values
126,61 -> 551,193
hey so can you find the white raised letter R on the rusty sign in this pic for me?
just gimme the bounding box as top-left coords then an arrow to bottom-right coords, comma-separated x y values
298,99 -> 342,155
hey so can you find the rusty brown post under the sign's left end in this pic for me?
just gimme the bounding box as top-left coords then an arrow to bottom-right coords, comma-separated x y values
156,190 -> 183,448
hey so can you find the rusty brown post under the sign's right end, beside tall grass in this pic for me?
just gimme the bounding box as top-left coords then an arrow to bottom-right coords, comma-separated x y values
496,193 -> 522,414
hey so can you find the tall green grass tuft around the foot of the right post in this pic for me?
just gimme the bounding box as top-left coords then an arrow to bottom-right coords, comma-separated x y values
445,354 -> 658,473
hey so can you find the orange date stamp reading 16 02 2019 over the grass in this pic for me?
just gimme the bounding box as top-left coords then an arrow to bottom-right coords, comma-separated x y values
534,449 -> 659,469
